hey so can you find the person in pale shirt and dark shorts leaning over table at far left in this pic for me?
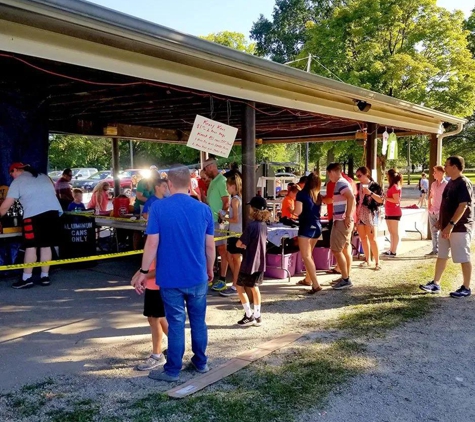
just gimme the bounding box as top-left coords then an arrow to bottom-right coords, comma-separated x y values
0,163 -> 63,289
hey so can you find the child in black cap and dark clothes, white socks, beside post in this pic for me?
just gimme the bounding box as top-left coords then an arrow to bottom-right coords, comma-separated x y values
236,196 -> 270,327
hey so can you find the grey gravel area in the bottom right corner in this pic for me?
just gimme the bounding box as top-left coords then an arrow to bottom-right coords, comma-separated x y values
299,252 -> 475,422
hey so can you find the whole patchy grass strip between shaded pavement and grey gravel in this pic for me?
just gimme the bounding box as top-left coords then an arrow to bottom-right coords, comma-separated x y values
0,249 -> 466,422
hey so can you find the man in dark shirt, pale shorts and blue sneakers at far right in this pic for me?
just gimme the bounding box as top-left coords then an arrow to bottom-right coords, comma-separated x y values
419,156 -> 473,298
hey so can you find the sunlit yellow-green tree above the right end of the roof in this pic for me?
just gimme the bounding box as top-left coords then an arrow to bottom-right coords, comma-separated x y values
301,0 -> 475,116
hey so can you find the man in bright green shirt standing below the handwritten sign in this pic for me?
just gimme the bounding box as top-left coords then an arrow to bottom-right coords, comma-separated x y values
203,158 -> 229,291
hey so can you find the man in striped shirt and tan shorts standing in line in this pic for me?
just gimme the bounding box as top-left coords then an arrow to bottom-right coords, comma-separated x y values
327,163 -> 355,290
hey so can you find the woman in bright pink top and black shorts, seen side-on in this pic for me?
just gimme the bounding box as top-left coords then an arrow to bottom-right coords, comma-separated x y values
383,169 -> 402,257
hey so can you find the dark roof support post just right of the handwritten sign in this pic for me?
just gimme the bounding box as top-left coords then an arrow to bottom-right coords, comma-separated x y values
241,102 -> 256,229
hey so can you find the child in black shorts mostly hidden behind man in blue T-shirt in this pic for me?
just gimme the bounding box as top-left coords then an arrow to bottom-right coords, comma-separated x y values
133,261 -> 168,371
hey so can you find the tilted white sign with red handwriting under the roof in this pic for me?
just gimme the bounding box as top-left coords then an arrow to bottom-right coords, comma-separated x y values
186,114 -> 237,158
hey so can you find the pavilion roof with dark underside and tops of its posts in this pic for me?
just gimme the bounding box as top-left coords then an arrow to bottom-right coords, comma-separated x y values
0,0 -> 465,211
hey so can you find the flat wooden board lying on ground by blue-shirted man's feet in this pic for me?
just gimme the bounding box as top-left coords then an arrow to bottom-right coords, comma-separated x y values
167,333 -> 302,399
